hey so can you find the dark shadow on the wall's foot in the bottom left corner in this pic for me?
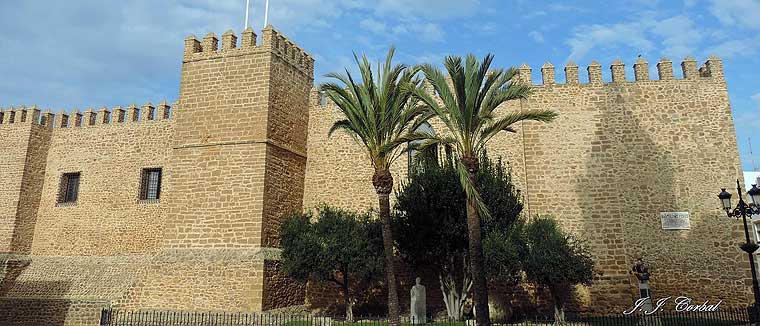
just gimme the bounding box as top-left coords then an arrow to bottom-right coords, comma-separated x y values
0,258 -> 71,326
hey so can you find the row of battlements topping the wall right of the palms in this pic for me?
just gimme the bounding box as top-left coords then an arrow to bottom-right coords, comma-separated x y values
517,56 -> 724,86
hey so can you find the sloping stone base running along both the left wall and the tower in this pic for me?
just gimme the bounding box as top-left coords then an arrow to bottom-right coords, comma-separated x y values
0,248 -> 306,325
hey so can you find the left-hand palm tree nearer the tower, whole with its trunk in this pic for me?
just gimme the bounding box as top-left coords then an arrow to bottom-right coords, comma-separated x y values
320,48 -> 424,326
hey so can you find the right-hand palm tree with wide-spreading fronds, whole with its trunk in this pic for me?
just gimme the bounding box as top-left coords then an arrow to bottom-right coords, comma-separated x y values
411,54 -> 557,326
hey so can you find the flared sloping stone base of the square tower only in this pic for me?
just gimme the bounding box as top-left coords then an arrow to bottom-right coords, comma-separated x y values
114,248 -> 305,312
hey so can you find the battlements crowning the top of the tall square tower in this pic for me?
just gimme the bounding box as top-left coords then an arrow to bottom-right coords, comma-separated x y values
183,25 -> 314,74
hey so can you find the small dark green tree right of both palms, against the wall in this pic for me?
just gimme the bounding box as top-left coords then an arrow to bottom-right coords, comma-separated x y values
523,216 -> 594,323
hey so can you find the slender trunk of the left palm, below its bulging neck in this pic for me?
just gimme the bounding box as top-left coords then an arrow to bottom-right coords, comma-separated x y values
377,192 -> 400,326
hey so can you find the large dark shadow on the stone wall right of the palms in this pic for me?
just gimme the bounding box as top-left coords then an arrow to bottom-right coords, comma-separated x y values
575,87 -> 686,313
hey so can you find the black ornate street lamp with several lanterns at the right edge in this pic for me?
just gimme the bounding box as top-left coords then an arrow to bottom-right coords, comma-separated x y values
718,180 -> 760,326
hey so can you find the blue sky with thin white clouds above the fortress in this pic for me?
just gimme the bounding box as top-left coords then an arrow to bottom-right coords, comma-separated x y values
0,0 -> 760,170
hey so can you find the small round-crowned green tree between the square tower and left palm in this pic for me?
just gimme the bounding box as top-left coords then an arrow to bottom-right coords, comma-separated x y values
280,206 -> 384,320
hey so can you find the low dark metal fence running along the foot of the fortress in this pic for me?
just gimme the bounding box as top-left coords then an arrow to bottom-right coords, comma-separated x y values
100,308 -> 750,326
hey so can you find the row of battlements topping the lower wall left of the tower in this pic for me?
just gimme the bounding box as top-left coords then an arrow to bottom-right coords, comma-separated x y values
0,101 -> 177,129
